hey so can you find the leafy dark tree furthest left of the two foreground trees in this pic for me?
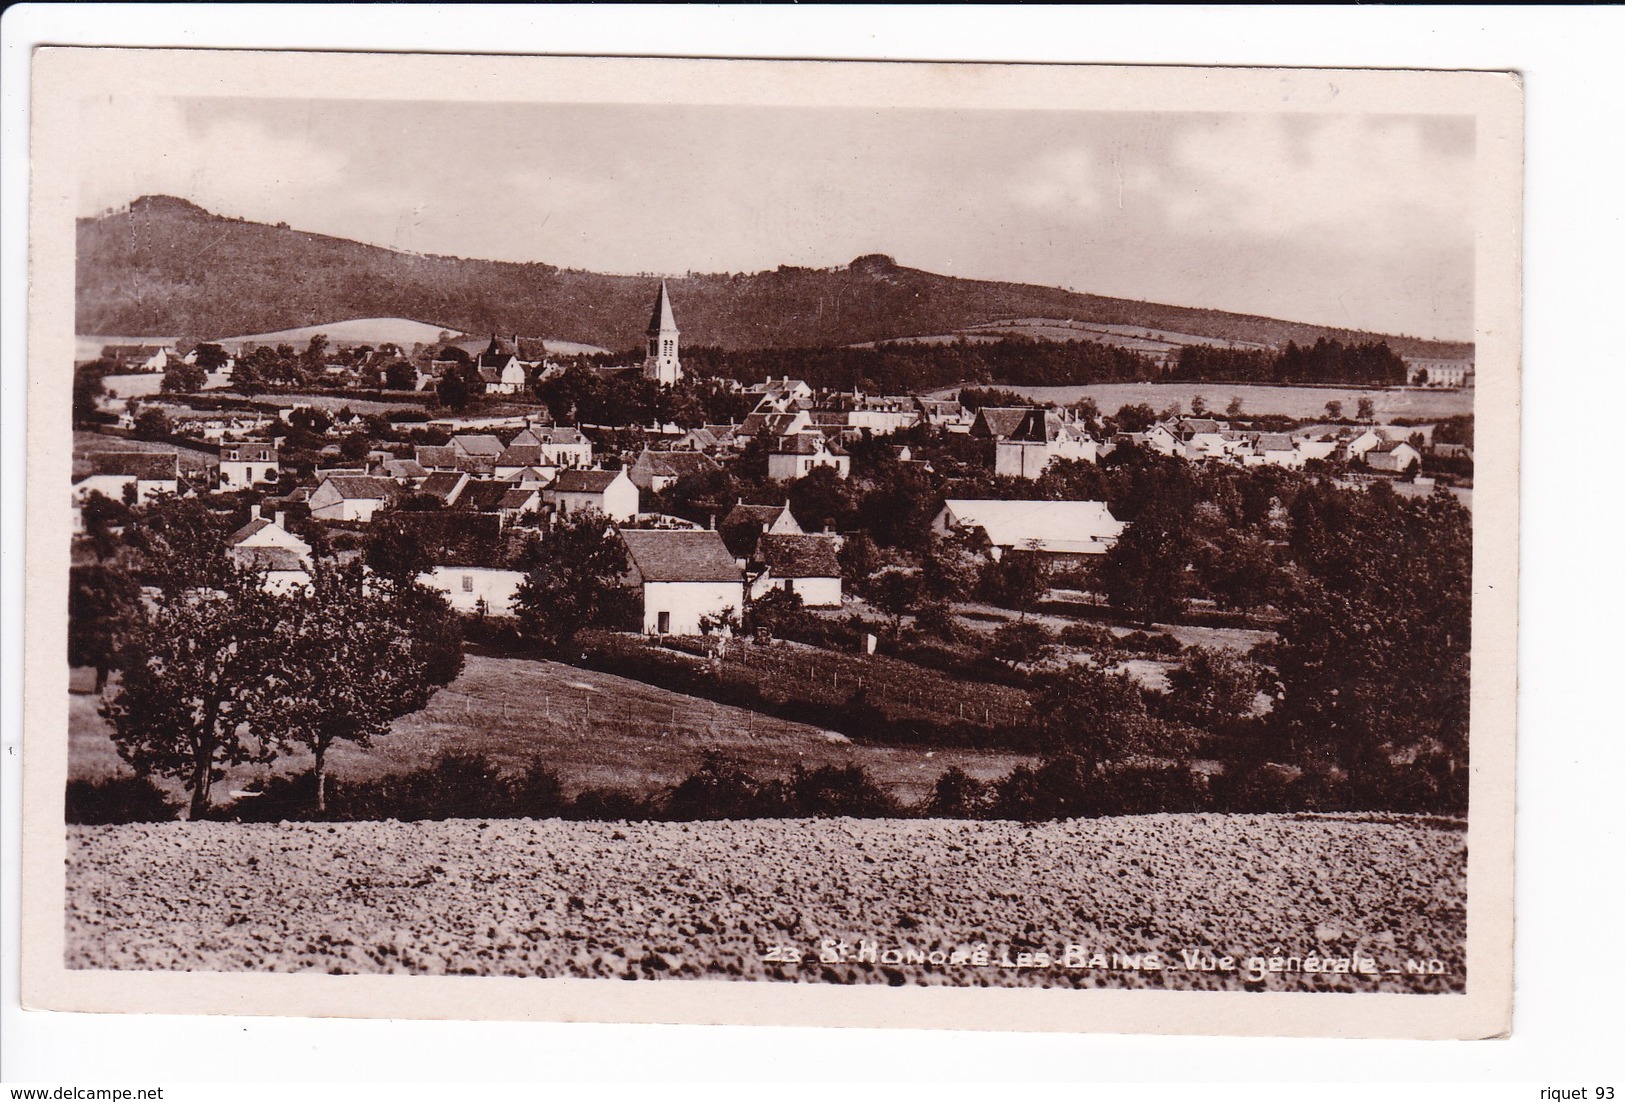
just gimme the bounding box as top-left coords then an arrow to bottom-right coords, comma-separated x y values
101,575 -> 286,819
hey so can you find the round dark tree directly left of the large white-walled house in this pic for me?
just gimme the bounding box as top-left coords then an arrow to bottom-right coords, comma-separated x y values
514,512 -> 631,650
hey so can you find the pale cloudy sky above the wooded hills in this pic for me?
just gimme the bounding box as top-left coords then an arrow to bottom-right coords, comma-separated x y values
78,94 -> 1474,340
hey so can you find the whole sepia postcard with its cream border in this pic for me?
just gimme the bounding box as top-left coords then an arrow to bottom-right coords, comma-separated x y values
24,49 -> 1521,1037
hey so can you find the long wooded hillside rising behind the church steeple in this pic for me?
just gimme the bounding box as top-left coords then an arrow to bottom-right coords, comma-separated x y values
76,195 -> 1471,356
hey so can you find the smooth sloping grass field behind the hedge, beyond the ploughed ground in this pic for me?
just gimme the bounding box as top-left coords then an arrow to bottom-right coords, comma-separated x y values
68,655 -> 1025,812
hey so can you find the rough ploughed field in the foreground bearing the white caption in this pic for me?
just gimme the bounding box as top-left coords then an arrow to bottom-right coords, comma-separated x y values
65,814 -> 1466,993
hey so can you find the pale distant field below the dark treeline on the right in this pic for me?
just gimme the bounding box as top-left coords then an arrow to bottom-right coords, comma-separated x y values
946,382 -> 1474,421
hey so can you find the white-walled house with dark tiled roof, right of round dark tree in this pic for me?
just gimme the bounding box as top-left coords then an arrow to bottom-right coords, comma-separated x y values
621,530 -> 744,636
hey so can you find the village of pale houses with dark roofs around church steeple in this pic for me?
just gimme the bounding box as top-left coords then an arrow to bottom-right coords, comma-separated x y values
73,284 -> 1471,646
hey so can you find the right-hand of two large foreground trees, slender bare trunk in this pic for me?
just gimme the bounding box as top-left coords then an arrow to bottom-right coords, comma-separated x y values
255,564 -> 460,814
